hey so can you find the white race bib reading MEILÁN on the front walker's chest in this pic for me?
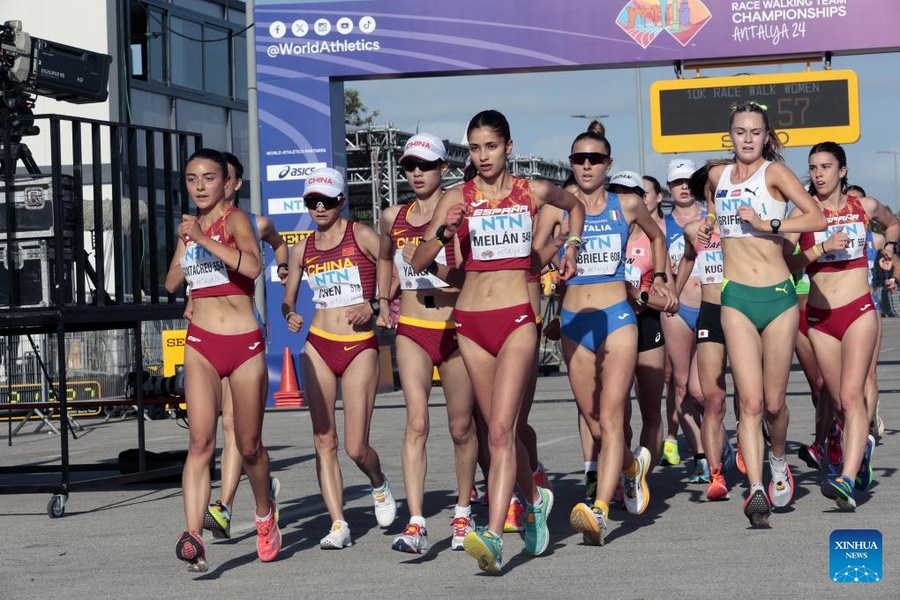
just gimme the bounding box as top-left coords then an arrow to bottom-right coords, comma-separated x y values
469,206 -> 531,260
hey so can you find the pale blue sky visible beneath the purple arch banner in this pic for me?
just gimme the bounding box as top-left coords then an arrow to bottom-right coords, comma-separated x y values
356,53 -> 900,211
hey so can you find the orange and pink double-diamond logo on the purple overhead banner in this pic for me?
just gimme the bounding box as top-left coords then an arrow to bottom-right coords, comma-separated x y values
616,0 -> 712,48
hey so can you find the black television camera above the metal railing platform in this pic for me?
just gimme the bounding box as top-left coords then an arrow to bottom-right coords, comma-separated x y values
0,21 -> 112,139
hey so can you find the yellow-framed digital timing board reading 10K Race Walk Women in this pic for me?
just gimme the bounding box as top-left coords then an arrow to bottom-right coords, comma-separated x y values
650,70 -> 860,153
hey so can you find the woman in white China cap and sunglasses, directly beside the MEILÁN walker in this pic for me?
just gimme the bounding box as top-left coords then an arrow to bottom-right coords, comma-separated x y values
377,133 -> 478,554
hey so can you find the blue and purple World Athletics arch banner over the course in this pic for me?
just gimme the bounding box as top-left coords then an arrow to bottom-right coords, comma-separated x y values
254,0 -> 900,404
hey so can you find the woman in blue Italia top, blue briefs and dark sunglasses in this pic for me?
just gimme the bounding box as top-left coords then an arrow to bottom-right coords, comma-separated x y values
536,139 -> 675,545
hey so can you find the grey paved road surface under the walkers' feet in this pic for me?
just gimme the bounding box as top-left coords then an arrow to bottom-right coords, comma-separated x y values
0,319 -> 900,600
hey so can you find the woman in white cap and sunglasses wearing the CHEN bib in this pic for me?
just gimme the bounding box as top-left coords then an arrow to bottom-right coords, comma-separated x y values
281,167 -> 397,550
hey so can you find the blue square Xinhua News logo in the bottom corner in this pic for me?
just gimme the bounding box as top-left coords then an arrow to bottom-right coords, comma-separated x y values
828,529 -> 883,583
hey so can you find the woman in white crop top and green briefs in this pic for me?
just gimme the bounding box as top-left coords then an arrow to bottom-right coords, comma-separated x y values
698,102 -> 825,527
